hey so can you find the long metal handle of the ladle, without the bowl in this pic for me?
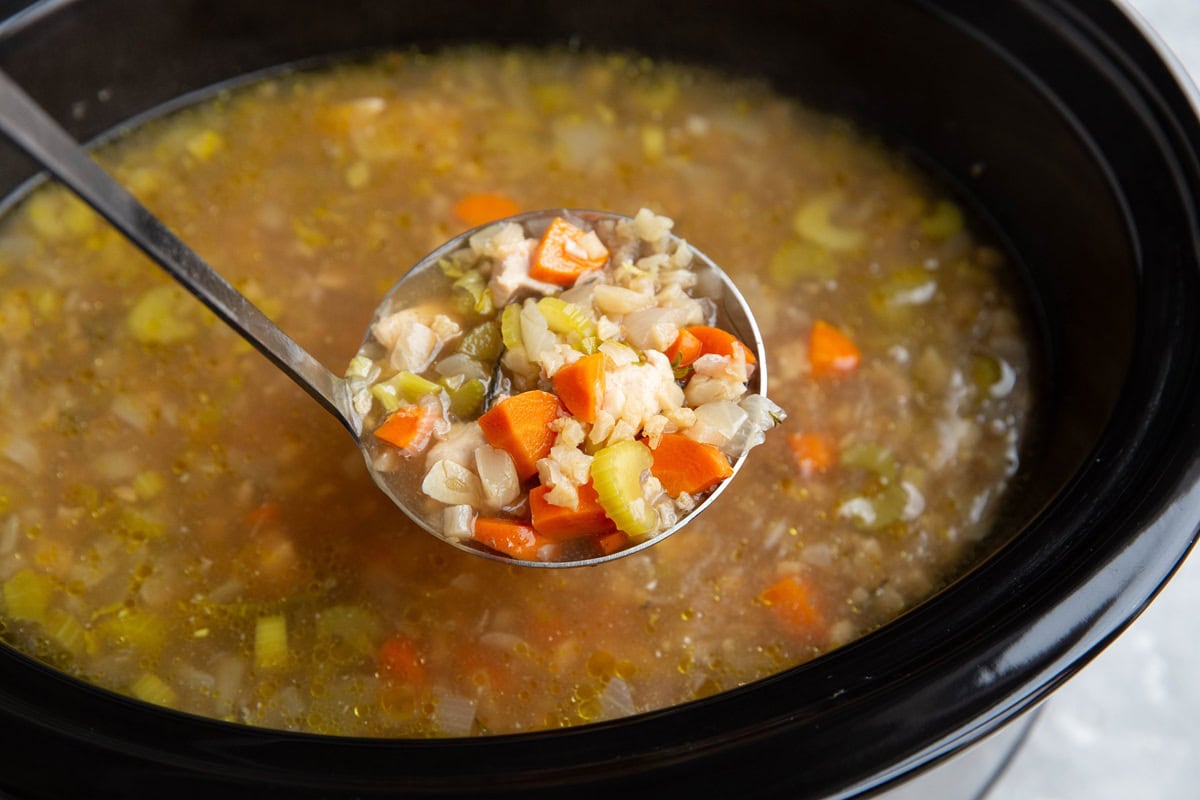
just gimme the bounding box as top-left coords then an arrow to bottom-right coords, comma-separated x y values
0,71 -> 359,438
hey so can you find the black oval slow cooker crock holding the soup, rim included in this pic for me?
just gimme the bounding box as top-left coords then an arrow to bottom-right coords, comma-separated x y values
0,0 -> 1200,798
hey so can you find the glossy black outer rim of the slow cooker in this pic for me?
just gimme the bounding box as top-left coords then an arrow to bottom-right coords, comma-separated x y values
0,0 -> 1200,796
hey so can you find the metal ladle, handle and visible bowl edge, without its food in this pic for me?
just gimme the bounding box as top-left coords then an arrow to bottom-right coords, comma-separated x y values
0,71 -> 767,567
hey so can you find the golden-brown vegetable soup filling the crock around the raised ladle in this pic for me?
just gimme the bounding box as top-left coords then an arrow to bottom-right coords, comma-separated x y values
0,49 -> 1031,736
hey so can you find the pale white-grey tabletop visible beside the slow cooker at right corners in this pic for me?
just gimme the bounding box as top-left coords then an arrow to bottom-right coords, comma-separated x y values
988,0 -> 1200,800
